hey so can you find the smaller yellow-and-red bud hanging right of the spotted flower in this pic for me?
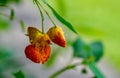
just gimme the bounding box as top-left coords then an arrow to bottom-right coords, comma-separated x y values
47,26 -> 66,47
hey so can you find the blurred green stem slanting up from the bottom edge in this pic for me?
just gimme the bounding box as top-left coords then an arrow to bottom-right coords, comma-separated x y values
49,63 -> 81,78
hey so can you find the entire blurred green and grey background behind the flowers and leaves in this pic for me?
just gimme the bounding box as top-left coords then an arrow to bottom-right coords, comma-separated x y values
0,0 -> 120,78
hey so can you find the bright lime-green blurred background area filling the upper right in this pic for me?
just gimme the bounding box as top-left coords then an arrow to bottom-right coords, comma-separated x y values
48,0 -> 120,70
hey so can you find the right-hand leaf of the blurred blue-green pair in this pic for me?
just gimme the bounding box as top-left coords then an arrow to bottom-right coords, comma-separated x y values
90,41 -> 103,62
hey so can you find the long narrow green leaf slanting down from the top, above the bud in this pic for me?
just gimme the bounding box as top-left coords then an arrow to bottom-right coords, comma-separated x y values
42,0 -> 77,34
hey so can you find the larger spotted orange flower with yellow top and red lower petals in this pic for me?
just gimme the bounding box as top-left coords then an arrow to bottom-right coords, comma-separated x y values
25,27 -> 51,64
